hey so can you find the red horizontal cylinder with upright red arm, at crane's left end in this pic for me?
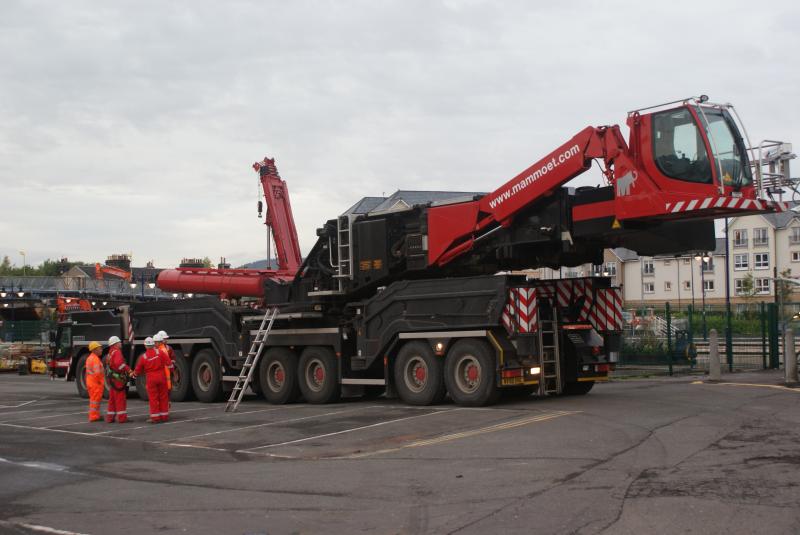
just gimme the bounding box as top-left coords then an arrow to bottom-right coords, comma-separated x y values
156,158 -> 302,298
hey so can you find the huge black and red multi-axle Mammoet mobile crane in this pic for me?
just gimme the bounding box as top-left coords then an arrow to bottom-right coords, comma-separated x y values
54,97 -> 787,405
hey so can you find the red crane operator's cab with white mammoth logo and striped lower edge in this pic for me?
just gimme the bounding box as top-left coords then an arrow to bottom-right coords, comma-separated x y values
614,95 -> 785,221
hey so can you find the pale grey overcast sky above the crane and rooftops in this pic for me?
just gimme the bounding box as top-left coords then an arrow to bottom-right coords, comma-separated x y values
0,0 -> 800,267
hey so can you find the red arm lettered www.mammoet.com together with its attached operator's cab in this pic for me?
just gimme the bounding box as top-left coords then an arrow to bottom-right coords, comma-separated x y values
428,98 -> 786,267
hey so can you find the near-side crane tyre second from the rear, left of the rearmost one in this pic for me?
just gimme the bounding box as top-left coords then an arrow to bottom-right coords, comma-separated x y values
394,341 -> 447,405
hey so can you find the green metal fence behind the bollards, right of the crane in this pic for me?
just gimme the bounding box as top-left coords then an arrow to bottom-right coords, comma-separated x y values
618,302 -> 800,375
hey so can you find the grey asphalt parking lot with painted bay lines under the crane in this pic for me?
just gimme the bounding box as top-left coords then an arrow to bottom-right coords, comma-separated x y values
0,372 -> 800,534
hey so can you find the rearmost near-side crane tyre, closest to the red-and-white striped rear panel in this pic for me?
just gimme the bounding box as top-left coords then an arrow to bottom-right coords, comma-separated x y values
444,338 -> 500,407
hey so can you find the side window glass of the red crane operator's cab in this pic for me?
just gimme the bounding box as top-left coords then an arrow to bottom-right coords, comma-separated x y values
653,108 -> 712,184
